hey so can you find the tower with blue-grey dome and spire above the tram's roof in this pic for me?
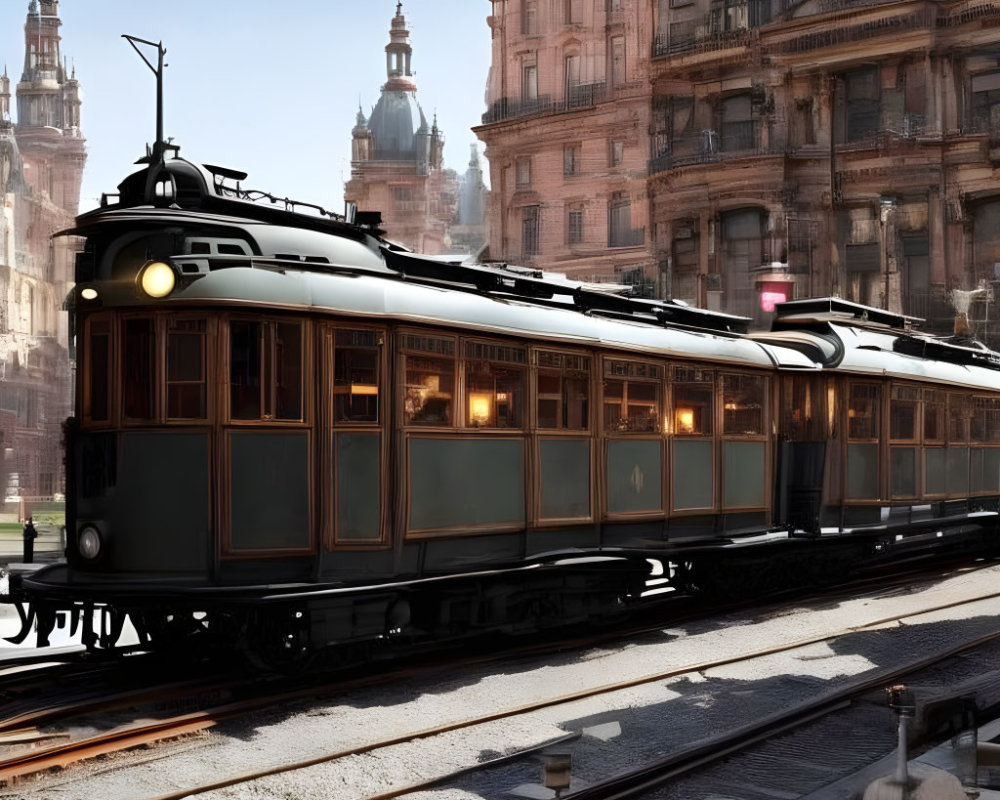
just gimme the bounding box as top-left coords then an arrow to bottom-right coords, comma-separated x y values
344,2 -> 457,254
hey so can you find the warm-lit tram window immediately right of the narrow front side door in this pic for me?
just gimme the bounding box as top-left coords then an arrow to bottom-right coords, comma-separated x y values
403,334 -> 455,426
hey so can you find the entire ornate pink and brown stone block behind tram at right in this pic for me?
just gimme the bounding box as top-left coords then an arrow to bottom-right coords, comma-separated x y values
477,0 -> 1000,345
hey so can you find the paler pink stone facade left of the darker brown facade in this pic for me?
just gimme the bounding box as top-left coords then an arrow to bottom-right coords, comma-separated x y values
475,0 -> 655,292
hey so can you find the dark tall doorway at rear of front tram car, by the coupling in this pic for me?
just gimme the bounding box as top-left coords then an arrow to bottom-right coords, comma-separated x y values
775,375 -> 834,533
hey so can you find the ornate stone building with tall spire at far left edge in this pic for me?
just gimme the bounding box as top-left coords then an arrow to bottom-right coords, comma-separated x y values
0,0 -> 86,497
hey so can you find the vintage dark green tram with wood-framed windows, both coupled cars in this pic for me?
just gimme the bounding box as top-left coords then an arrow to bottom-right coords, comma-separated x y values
6,147 -> 1000,660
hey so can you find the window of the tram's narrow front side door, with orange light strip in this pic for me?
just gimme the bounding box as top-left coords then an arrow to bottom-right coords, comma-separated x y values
333,330 -> 379,422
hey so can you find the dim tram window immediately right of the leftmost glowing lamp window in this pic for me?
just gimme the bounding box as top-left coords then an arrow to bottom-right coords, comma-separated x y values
535,351 -> 590,431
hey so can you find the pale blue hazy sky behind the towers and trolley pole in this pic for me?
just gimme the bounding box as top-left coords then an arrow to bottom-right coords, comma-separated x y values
0,0 -> 490,211
